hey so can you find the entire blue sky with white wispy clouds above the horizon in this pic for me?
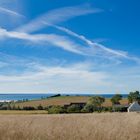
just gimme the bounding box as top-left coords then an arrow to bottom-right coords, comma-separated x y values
0,0 -> 140,94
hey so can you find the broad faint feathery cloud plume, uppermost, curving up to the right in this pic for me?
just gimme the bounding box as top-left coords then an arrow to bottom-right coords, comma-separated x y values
16,5 -> 103,33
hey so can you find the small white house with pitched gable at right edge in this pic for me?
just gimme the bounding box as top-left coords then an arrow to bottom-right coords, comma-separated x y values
127,102 -> 140,112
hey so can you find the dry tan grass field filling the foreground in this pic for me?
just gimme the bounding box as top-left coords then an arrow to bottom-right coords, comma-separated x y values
0,113 -> 140,140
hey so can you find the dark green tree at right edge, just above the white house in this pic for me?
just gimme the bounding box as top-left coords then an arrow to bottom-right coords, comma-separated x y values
128,91 -> 140,103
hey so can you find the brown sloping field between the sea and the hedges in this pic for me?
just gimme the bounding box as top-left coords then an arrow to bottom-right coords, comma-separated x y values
13,96 -> 128,107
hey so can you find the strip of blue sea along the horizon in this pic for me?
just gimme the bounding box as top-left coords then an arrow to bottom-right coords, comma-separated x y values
0,94 -> 127,101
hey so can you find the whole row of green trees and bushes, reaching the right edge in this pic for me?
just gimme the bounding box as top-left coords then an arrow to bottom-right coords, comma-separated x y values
48,91 -> 140,114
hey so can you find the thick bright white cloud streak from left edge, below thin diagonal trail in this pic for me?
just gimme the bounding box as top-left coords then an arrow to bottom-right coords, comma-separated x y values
0,29 -> 87,55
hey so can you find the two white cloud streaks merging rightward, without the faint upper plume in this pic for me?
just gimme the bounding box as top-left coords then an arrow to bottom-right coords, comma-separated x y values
0,25 -> 140,63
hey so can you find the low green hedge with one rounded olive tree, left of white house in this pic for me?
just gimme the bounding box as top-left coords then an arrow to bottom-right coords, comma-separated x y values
48,96 -> 127,114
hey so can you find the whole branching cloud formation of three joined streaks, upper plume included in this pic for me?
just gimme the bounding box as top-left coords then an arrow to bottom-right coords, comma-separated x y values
0,5 -> 139,61
